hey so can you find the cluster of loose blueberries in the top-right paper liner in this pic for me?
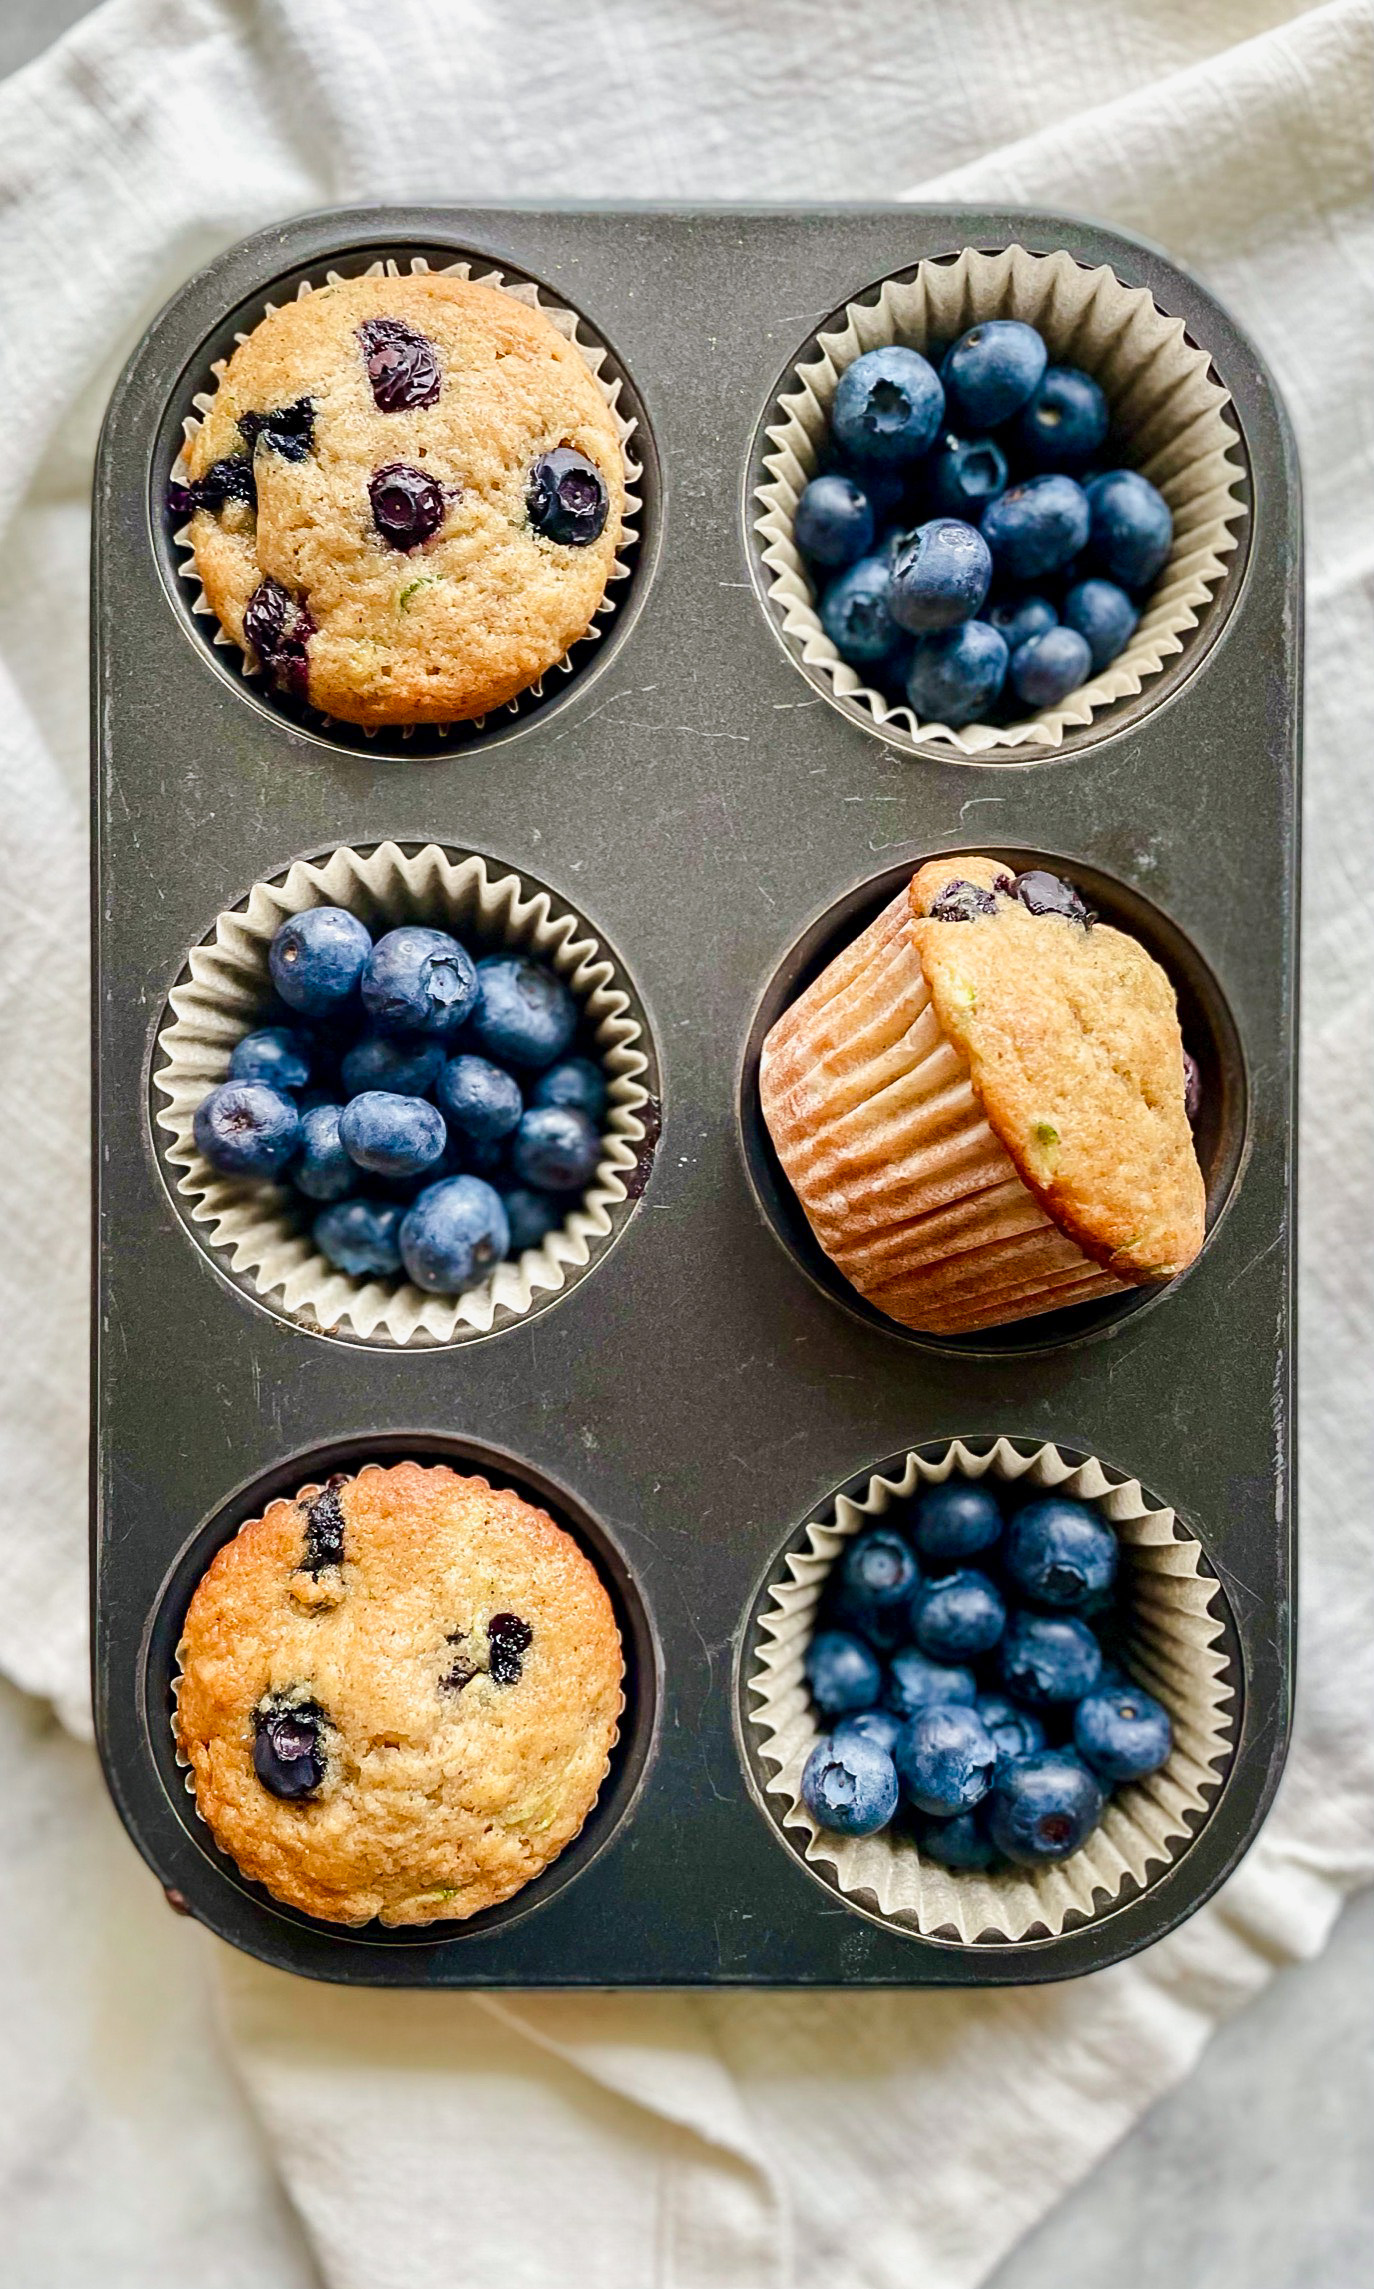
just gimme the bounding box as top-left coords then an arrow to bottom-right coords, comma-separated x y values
792,318 -> 1172,730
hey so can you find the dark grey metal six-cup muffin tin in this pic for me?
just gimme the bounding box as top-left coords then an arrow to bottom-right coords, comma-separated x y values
92,206 -> 1301,1987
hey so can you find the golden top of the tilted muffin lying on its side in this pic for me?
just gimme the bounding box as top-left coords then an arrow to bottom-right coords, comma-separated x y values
909,856 -> 1207,1282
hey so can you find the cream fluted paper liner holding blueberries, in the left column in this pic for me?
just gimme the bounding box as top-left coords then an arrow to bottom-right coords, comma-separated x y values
153,842 -> 655,1346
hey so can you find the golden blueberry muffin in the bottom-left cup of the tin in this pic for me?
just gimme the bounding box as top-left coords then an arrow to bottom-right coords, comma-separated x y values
176,1463 -> 623,1925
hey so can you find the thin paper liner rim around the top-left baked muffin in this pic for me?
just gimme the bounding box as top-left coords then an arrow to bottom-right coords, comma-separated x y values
167,254 -> 643,739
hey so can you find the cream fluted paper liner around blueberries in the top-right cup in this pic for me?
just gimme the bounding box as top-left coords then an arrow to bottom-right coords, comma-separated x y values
756,247 -> 1246,762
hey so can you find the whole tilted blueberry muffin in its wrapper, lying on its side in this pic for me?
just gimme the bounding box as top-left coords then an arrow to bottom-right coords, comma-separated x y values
760,856 -> 1205,1334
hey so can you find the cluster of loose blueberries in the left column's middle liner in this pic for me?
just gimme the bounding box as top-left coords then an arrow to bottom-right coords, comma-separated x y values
195,906 -> 607,1296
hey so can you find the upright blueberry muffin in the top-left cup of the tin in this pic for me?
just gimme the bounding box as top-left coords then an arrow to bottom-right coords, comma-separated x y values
172,272 -> 625,726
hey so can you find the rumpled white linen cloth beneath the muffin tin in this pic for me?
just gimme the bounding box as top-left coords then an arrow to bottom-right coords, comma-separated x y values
0,0 -> 1374,2289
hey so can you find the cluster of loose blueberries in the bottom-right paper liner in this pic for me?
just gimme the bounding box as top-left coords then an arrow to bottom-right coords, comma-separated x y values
802,1479 -> 1172,1870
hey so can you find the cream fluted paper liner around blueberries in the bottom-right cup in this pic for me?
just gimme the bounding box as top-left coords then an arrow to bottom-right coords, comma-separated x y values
747,1437 -> 1239,1946
